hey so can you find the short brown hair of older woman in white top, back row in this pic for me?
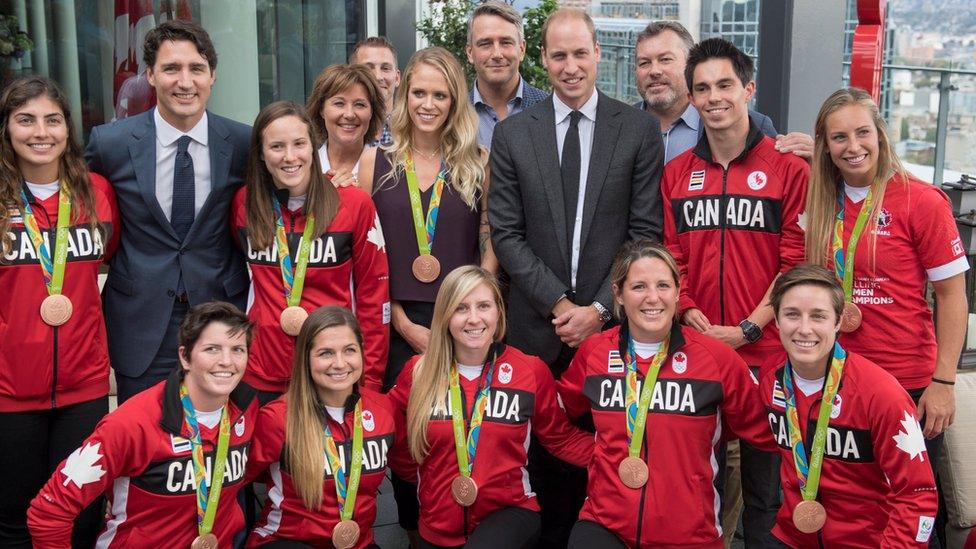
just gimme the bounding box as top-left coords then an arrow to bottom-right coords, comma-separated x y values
305,65 -> 386,145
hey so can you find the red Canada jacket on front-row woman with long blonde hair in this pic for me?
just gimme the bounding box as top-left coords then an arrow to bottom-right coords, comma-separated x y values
389,346 -> 593,546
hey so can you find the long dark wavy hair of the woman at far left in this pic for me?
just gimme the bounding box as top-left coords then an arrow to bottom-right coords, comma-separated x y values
0,76 -> 99,256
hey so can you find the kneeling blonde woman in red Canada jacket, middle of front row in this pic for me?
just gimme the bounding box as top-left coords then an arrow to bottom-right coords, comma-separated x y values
390,265 -> 593,548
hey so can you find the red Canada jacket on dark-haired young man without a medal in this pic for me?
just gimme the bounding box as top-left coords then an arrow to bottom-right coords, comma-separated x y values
661,122 -> 810,366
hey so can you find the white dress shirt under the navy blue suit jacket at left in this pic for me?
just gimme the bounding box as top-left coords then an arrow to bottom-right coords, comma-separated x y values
153,108 -> 212,220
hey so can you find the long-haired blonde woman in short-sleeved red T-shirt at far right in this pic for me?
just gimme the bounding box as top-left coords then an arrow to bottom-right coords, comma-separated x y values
806,88 -> 969,478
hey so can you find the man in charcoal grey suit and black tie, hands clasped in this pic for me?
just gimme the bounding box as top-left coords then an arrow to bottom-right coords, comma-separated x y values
488,9 -> 663,547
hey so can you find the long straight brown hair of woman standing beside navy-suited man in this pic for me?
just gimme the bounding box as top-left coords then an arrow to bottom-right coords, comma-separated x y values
246,101 -> 339,250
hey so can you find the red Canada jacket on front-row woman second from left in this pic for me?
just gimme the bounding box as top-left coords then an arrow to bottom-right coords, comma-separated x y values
248,389 -> 403,549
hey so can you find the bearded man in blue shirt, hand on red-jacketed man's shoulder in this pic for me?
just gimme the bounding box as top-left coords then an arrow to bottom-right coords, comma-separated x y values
634,21 -> 813,163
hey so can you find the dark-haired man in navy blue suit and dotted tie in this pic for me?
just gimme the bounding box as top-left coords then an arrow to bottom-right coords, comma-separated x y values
85,20 -> 251,403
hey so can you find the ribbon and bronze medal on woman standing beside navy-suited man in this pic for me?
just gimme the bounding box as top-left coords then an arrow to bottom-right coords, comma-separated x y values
271,195 -> 315,337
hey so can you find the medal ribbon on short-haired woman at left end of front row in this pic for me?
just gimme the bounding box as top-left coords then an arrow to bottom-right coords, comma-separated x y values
180,383 -> 230,536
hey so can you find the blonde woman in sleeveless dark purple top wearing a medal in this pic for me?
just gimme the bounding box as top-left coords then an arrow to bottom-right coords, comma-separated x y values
359,48 -> 497,388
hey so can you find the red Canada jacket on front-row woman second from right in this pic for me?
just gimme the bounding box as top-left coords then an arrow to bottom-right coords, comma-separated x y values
557,325 -> 775,549
